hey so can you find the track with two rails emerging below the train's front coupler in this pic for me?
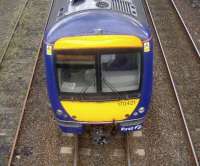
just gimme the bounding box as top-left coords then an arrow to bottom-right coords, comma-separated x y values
73,134 -> 133,166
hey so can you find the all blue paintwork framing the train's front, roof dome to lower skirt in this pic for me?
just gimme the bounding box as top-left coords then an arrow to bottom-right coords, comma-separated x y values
43,11 -> 153,133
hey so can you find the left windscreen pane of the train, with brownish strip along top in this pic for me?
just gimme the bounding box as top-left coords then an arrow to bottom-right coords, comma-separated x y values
57,55 -> 96,93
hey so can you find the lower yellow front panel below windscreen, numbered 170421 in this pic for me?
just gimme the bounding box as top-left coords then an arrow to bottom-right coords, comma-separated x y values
61,99 -> 139,123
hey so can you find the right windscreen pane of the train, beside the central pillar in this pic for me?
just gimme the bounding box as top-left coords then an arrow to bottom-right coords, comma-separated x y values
101,52 -> 141,92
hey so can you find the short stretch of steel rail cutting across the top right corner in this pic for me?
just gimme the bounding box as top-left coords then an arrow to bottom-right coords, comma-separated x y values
170,0 -> 200,58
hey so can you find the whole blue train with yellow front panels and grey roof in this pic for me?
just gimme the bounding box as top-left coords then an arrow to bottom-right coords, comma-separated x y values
43,0 -> 153,134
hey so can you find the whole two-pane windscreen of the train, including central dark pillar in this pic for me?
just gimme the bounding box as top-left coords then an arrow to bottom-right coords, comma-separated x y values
56,51 -> 142,94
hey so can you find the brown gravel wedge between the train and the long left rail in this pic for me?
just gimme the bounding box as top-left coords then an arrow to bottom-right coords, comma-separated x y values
13,55 -> 73,166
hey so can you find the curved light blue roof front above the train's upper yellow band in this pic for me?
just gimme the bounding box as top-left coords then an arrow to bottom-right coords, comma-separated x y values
45,10 -> 150,43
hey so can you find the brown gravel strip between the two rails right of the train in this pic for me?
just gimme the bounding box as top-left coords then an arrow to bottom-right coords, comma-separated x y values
145,0 -> 200,162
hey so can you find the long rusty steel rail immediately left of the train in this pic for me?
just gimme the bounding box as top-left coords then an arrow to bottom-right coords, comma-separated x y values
8,0 -> 54,166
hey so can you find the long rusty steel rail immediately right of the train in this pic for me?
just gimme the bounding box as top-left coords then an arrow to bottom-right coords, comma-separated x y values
144,0 -> 199,166
